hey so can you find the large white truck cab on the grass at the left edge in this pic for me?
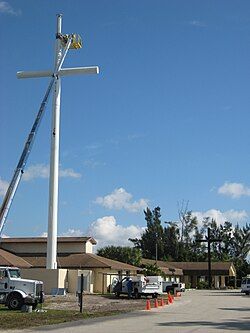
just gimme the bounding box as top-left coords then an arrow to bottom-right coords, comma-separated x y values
0,266 -> 43,310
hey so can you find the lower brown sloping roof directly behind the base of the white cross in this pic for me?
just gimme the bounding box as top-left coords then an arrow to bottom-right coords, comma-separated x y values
22,253 -> 140,270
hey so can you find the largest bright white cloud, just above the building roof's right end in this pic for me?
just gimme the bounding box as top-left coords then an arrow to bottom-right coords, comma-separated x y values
87,216 -> 144,248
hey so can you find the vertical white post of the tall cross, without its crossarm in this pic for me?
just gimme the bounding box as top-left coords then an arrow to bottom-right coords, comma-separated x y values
46,14 -> 62,269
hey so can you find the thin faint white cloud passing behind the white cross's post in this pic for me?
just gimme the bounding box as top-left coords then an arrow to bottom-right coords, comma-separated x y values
23,164 -> 81,181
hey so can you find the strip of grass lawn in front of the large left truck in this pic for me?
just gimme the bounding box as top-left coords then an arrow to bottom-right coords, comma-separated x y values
0,305 -> 120,331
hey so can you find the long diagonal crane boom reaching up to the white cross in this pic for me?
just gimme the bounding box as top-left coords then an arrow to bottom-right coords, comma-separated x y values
0,35 -> 72,238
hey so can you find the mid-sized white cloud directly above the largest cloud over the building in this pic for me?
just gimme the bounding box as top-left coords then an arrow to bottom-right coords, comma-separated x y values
95,187 -> 148,213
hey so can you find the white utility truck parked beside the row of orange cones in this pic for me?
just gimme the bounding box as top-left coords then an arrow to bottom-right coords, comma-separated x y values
113,276 -> 162,298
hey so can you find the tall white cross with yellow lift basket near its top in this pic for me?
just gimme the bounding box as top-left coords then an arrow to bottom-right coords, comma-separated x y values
17,14 -> 99,269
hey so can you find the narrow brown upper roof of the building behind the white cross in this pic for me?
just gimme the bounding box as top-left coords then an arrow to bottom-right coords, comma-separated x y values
1,237 -> 97,245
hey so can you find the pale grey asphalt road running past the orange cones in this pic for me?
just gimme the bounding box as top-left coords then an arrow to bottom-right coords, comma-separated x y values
10,290 -> 250,333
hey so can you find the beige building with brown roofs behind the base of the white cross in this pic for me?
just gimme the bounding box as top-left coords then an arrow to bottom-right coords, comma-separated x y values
0,237 -> 139,294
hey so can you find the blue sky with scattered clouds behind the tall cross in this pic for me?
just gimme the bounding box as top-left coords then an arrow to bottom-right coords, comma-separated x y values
0,0 -> 250,246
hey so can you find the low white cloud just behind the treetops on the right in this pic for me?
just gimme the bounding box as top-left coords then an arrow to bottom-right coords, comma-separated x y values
192,209 -> 248,224
